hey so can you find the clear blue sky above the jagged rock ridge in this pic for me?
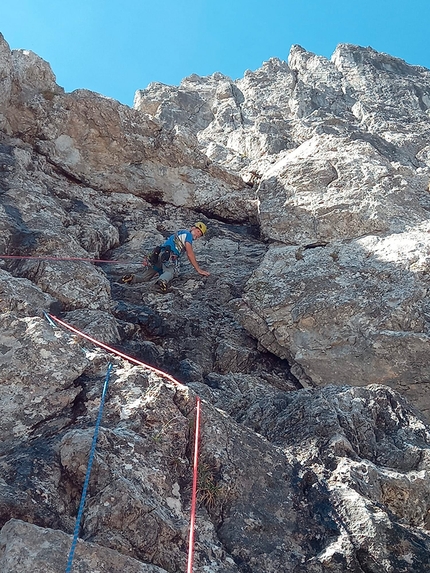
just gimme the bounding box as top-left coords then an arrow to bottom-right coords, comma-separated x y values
0,0 -> 430,105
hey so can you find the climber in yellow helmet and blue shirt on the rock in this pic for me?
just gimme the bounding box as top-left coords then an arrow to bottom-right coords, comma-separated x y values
121,221 -> 209,292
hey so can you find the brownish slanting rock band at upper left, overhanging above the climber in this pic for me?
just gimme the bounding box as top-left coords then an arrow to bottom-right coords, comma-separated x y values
0,33 -> 250,220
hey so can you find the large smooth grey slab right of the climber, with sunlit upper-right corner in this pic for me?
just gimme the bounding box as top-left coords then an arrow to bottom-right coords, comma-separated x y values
238,225 -> 430,412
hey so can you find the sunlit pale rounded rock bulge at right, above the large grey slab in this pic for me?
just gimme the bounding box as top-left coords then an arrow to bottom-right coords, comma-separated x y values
255,135 -> 429,245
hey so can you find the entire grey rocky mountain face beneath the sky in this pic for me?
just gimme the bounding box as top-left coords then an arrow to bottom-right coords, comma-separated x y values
0,32 -> 430,573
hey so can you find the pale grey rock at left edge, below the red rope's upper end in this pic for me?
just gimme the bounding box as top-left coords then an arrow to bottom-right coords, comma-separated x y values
0,313 -> 88,450
